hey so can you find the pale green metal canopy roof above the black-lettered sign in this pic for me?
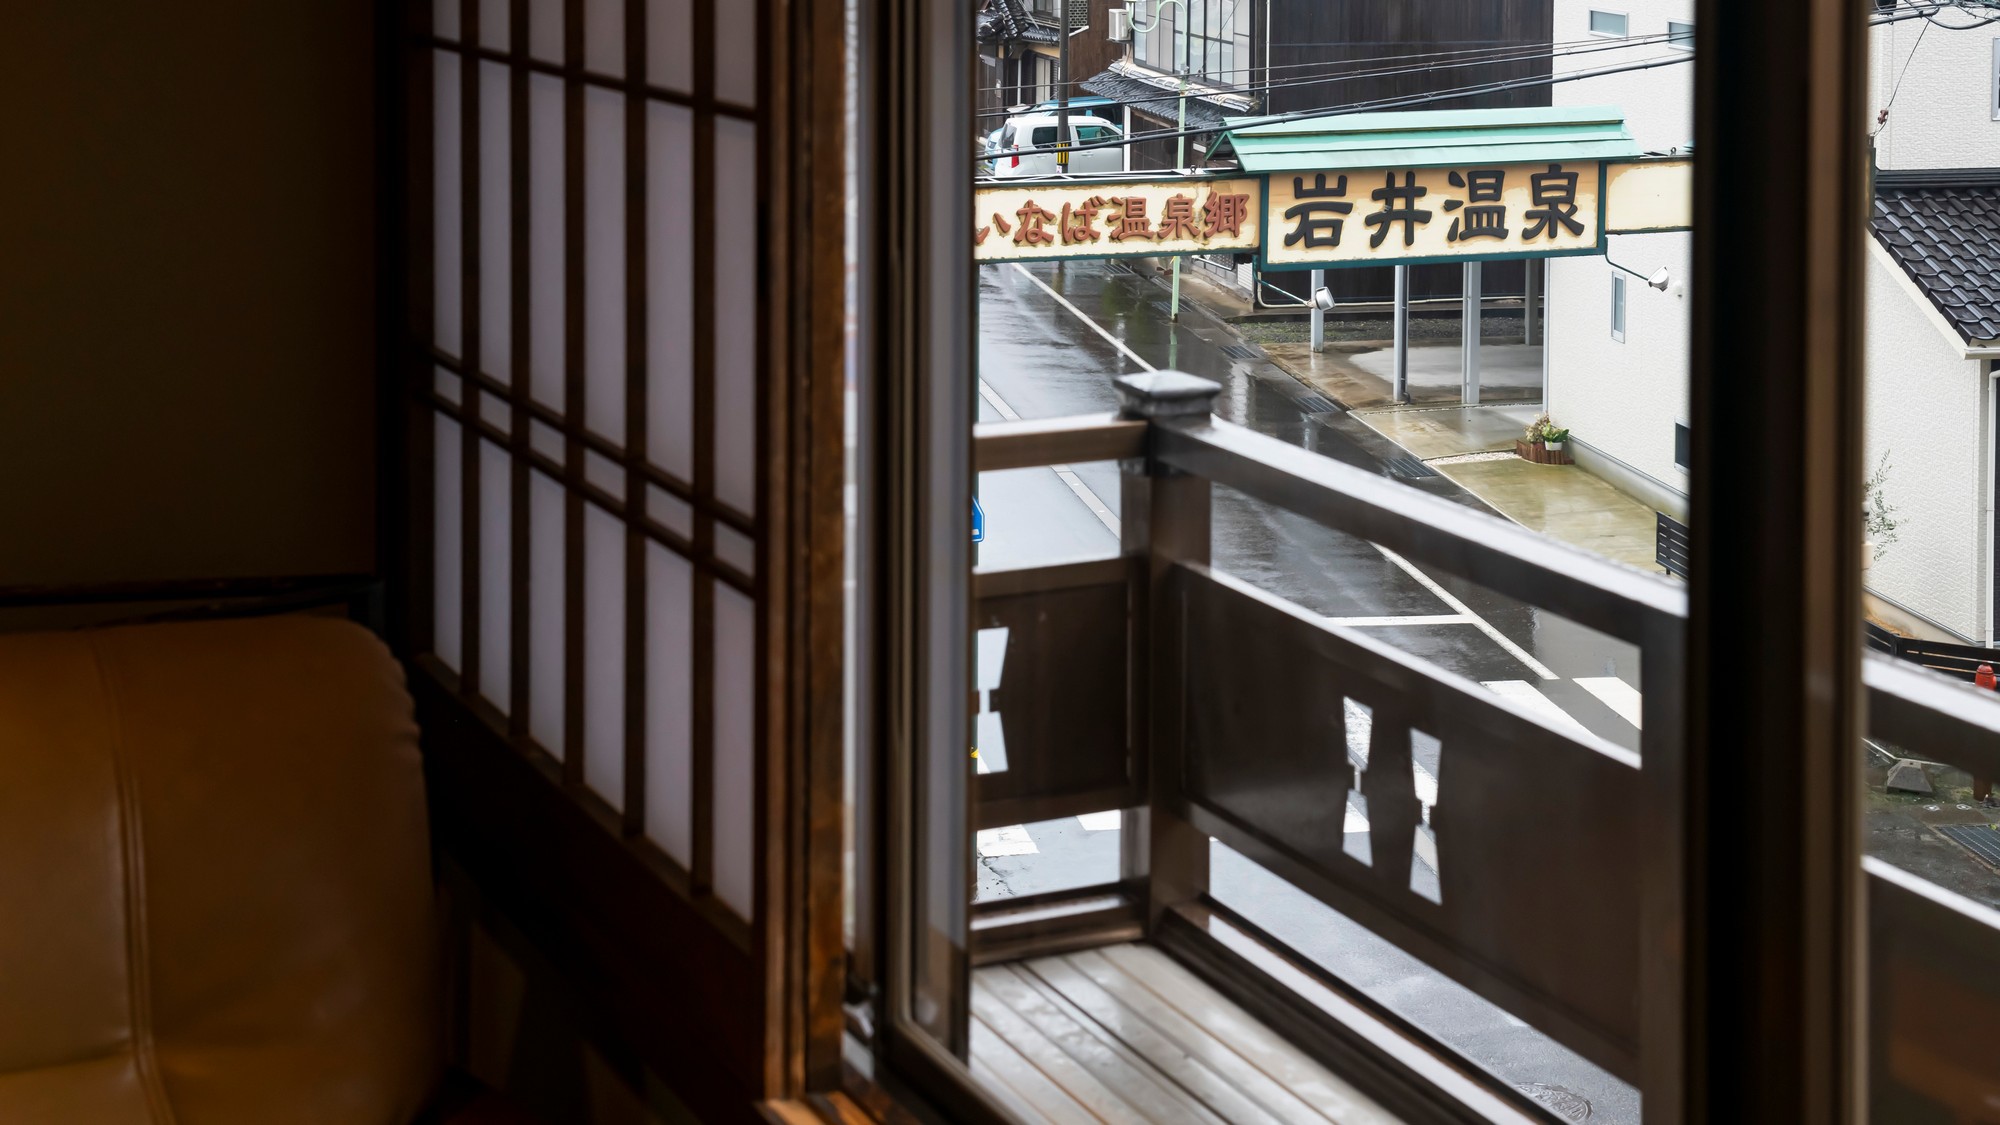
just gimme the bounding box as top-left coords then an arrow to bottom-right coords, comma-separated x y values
1222,106 -> 1640,172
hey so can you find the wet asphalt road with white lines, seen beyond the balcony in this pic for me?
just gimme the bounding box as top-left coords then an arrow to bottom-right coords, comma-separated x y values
978,262 -> 1638,1123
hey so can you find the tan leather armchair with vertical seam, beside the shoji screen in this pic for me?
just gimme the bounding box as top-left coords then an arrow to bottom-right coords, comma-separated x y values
0,617 -> 508,1125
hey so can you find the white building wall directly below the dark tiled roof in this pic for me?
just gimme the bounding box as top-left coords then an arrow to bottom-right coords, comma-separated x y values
1866,254 -> 1988,643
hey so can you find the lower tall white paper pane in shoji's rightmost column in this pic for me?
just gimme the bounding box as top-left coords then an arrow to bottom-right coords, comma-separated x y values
712,583 -> 756,921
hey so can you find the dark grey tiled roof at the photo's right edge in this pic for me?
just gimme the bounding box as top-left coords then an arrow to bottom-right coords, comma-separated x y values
1872,168 -> 2000,342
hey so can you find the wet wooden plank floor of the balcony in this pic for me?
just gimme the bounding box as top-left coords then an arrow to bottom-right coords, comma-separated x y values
972,945 -> 1396,1125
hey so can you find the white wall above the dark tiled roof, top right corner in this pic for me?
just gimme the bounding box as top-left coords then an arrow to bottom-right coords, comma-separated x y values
1868,10 -> 2000,170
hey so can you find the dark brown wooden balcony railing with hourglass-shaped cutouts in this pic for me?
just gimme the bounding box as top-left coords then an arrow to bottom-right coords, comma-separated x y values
974,372 -> 2000,1119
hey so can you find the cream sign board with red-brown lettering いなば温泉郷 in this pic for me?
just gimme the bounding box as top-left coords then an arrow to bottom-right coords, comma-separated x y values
972,178 -> 1264,262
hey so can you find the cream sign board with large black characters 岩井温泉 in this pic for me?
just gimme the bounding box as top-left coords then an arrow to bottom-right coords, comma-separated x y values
1264,160 -> 1602,268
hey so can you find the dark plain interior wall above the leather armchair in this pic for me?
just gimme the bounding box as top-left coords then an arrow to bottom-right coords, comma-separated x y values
0,0 -> 376,587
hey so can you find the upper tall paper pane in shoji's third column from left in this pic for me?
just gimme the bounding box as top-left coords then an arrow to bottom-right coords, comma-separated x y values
528,74 -> 568,410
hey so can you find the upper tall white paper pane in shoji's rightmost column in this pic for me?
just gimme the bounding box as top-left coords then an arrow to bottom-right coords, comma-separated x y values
714,116 -> 762,512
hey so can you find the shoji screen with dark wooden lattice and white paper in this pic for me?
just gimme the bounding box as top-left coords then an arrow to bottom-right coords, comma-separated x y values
412,0 -> 774,936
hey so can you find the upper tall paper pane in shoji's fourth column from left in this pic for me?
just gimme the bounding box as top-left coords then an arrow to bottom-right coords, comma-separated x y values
584,86 -> 626,444
